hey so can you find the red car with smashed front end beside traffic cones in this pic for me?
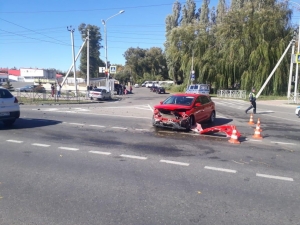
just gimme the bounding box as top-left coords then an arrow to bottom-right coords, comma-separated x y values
152,93 -> 216,130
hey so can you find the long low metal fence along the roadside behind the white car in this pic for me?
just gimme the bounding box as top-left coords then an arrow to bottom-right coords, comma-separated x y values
13,90 -> 89,102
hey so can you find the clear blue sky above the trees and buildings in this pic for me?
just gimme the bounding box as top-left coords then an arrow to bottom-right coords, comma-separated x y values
0,0 -> 300,72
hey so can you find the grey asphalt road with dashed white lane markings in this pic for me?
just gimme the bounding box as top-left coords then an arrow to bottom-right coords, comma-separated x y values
0,88 -> 300,225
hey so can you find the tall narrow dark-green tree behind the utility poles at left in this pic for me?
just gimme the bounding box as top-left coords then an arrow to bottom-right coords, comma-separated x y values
78,23 -> 105,78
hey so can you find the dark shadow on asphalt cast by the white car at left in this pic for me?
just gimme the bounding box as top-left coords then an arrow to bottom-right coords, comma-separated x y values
0,118 -> 62,130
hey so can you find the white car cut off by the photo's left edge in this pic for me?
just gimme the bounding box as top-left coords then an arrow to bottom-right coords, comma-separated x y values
0,87 -> 20,126
